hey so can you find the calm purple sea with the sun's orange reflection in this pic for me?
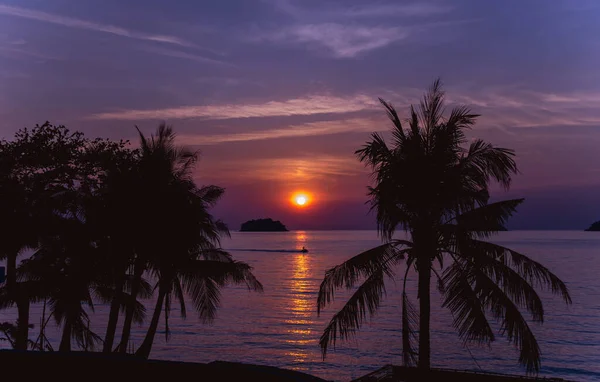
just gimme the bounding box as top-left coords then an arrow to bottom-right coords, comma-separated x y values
0,231 -> 600,381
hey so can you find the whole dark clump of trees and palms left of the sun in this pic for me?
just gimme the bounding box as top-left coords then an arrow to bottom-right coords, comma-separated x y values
0,123 -> 262,357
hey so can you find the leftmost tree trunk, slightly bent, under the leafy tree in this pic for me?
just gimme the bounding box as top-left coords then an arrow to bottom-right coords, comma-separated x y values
6,252 -> 29,350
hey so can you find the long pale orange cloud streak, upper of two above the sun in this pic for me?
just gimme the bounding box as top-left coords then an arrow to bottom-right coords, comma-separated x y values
89,95 -> 379,121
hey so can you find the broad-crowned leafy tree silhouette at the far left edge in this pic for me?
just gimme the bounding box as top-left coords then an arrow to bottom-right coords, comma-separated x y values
0,122 -> 134,350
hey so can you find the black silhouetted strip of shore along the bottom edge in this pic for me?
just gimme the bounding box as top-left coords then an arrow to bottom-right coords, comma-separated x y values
0,350 -> 580,382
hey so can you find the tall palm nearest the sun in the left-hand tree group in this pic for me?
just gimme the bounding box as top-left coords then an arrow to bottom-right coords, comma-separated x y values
127,124 -> 262,357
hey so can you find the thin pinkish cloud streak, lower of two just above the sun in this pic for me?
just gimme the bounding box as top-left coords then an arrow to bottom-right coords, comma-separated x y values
178,118 -> 376,145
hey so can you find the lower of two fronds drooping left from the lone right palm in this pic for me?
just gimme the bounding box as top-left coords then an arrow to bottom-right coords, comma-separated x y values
319,269 -> 385,359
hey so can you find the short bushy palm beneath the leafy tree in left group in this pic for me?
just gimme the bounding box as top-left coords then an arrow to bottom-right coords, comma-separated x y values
17,203 -> 150,351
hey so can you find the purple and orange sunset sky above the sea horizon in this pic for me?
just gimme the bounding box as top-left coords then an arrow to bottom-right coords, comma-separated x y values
0,0 -> 600,229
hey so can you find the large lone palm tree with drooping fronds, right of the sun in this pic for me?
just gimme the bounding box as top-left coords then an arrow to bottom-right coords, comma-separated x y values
317,80 -> 571,371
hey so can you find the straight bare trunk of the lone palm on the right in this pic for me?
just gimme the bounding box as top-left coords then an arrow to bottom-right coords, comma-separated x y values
417,256 -> 431,370
